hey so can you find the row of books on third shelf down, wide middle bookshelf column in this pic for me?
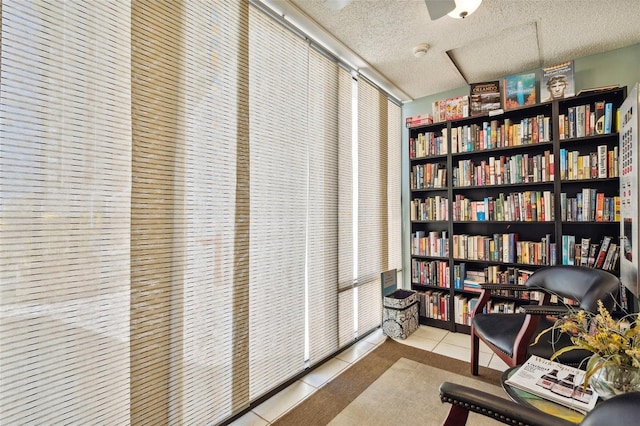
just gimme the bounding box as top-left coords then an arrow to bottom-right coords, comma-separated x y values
453,191 -> 555,222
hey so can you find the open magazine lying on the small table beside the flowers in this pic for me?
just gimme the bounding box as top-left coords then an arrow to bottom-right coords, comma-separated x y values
506,355 -> 598,414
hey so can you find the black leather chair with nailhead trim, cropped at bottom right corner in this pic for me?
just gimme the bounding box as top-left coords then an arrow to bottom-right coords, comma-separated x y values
440,382 -> 640,426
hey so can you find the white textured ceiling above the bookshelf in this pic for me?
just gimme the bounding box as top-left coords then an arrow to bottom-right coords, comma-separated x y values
264,0 -> 640,101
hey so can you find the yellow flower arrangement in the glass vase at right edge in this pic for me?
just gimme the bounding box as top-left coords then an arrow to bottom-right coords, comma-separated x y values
535,301 -> 640,392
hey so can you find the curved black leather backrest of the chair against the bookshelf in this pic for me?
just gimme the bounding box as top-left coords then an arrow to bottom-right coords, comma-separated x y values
525,265 -> 620,312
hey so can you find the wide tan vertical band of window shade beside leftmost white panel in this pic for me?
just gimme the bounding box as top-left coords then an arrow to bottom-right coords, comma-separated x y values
131,1 -> 185,424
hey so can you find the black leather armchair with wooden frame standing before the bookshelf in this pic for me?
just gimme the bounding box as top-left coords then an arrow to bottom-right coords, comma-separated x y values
471,265 -> 620,375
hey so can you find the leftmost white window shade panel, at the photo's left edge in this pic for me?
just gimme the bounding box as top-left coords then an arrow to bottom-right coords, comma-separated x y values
0,1 -> 131,425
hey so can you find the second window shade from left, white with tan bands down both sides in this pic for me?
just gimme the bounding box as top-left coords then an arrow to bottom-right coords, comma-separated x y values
131,1 -> 249,424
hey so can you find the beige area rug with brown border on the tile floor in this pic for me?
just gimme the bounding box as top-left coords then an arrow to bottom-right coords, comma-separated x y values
273,339 -> 505,426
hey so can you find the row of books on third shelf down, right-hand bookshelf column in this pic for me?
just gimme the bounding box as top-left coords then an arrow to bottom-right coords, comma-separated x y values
560,188 -> 620,222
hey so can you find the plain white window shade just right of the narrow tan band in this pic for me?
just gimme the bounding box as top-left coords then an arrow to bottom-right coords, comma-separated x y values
245,8 -> 309,399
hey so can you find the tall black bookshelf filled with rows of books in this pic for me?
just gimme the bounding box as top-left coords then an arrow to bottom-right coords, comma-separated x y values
409,88 -> 626,333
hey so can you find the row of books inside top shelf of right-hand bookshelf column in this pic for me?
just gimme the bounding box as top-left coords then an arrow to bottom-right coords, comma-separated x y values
558,101 -> 614,139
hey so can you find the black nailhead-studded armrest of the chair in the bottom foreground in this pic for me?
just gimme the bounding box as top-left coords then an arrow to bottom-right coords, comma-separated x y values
440,382 -> 575,426
